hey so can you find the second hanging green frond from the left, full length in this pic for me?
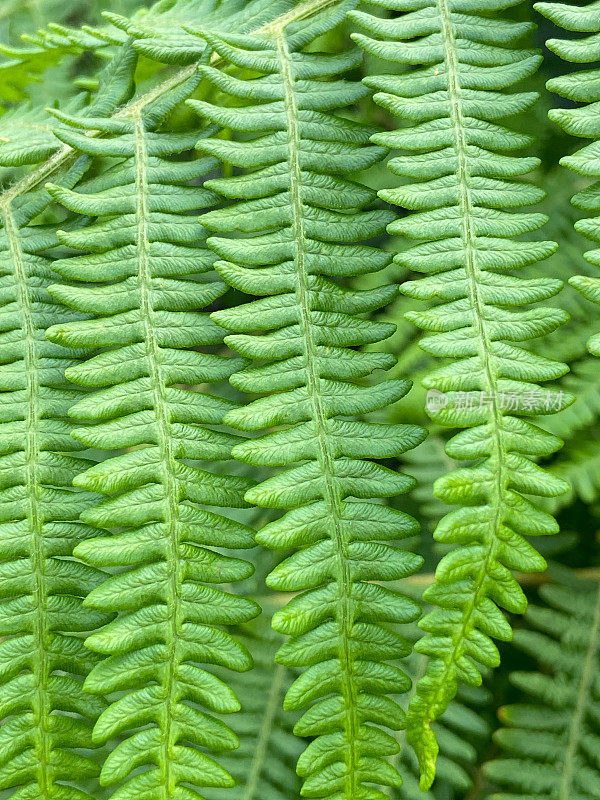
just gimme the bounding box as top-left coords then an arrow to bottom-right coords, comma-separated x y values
48,61 -> 259,800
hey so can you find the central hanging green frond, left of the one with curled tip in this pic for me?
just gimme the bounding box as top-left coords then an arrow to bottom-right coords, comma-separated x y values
190,18 -> 423,800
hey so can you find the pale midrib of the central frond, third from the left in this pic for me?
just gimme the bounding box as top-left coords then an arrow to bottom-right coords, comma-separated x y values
275,28 -> 359,800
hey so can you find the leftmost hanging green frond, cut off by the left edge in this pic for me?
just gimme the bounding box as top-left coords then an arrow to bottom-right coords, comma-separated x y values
0,42 -> 136,800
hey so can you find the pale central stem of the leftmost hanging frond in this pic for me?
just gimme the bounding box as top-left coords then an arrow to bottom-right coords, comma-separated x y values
0,202 -> 53,800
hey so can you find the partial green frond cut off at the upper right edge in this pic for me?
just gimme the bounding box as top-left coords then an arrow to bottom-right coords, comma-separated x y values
535,2 -> 600,356
